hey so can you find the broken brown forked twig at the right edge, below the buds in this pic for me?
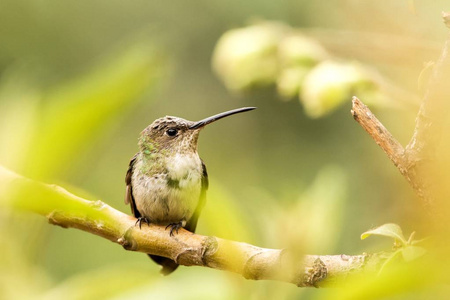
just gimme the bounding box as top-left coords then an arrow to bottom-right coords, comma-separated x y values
351,13 -> 450,215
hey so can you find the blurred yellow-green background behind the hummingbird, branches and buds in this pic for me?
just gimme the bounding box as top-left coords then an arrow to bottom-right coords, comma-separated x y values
0,0 -> 450,299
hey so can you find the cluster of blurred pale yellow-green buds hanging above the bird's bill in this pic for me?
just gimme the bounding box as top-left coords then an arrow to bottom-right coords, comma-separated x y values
212,20 -> 417,118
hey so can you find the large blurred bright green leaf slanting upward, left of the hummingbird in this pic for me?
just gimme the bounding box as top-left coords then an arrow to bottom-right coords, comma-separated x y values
27,42 -> 166,177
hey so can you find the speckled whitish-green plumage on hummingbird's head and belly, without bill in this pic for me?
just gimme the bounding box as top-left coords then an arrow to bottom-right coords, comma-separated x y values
131,116 -> 203,227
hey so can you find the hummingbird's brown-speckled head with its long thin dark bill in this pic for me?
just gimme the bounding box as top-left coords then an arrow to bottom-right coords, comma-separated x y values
139,107 -> 256,155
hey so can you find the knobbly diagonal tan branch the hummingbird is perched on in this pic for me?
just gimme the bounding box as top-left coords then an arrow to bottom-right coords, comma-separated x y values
0,166 -> 386,287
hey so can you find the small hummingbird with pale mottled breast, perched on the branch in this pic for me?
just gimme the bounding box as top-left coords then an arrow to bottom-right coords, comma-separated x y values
125,107 -> 256,275
